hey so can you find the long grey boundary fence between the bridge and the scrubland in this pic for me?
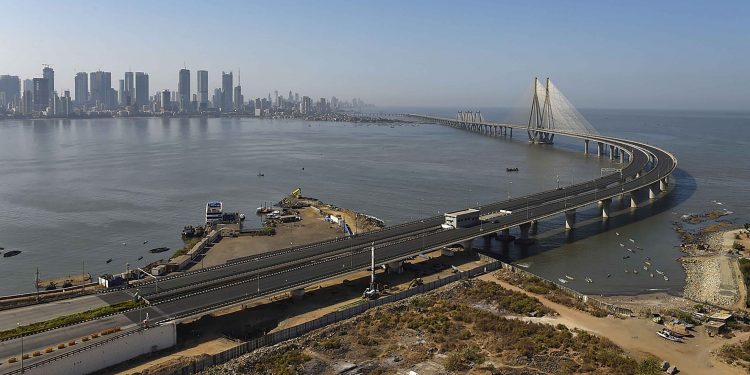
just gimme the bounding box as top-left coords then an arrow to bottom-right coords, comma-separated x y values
175,260 -> 503,375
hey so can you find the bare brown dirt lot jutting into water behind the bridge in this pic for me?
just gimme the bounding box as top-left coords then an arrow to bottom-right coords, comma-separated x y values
191,207 -> 344,269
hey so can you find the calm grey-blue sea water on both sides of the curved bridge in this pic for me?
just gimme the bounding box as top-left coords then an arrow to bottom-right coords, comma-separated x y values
0,108 -> 750,294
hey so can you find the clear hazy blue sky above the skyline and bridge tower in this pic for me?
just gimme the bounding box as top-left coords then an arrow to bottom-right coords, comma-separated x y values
0,0 -> 750,110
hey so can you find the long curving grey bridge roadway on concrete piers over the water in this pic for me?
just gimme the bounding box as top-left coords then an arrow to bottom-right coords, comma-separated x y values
0,115 -> 677,374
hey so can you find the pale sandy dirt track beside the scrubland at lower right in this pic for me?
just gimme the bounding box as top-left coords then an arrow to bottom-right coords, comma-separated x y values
479,274 -> 750,375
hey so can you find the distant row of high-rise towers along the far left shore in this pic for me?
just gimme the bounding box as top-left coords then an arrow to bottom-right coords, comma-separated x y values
0,64 -> 364,116
